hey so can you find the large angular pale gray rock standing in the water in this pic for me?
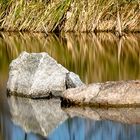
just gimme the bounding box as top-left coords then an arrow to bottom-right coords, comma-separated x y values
7,52 -> 83,98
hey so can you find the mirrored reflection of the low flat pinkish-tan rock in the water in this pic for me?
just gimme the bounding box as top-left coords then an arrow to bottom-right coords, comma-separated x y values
63,107 -> 140,124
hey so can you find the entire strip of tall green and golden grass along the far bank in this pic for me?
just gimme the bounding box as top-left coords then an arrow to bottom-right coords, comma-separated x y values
0,0 -> 140,32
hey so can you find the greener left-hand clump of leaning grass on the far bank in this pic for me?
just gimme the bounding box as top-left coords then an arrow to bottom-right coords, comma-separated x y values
0,0 -> 70,32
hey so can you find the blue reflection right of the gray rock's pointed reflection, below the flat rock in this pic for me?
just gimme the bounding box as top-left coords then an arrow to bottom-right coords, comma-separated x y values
48,117 -> 140,140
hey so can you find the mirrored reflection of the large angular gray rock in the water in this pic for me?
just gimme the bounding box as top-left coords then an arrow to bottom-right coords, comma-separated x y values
8,96 -> 68,136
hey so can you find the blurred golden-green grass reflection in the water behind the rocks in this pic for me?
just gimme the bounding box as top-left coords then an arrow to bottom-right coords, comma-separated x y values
0,33 -> 140,83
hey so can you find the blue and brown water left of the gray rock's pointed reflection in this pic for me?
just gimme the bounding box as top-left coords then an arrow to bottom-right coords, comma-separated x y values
0,92 -> 44,140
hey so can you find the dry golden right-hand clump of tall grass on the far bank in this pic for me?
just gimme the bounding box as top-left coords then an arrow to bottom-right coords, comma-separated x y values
64,0 -> 140,34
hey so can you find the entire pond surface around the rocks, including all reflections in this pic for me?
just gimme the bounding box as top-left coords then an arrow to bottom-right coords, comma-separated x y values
0,32 -> 140,140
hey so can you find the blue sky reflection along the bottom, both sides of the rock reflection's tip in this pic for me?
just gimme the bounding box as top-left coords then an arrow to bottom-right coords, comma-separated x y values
1,110 -> 140,140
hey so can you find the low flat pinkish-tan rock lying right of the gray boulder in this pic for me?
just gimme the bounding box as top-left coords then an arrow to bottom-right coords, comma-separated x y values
63,80 -> 140,106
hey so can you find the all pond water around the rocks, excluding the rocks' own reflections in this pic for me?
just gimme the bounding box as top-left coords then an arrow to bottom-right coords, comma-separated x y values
0,33 -> 140,140
